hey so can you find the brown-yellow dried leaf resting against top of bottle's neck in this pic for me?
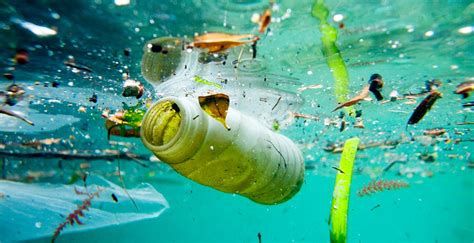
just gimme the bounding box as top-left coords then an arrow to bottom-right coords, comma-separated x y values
199,94 -> 230,130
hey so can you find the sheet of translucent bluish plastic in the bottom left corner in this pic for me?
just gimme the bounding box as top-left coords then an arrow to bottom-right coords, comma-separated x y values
0,177 -> 169,242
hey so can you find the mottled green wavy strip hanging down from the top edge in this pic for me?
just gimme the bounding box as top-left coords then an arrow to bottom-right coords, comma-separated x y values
312,0 -> 355,115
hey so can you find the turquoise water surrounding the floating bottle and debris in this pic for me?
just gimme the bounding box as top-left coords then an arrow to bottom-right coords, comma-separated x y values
0,0 -> 474,242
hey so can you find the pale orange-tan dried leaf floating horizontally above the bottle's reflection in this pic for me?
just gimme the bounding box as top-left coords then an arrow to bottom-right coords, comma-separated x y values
192,33 -> 259,53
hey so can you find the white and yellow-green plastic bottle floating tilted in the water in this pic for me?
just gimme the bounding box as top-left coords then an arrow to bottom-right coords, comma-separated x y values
141,97 -> 304,204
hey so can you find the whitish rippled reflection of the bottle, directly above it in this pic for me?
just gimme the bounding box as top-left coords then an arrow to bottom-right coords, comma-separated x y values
141,37 -> 304,128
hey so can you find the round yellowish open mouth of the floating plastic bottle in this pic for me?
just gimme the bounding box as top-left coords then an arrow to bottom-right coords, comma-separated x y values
142,100 -> 181,146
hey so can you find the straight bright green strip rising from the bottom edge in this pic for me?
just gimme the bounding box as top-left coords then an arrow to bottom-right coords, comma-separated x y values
329,137 -> 360,243
